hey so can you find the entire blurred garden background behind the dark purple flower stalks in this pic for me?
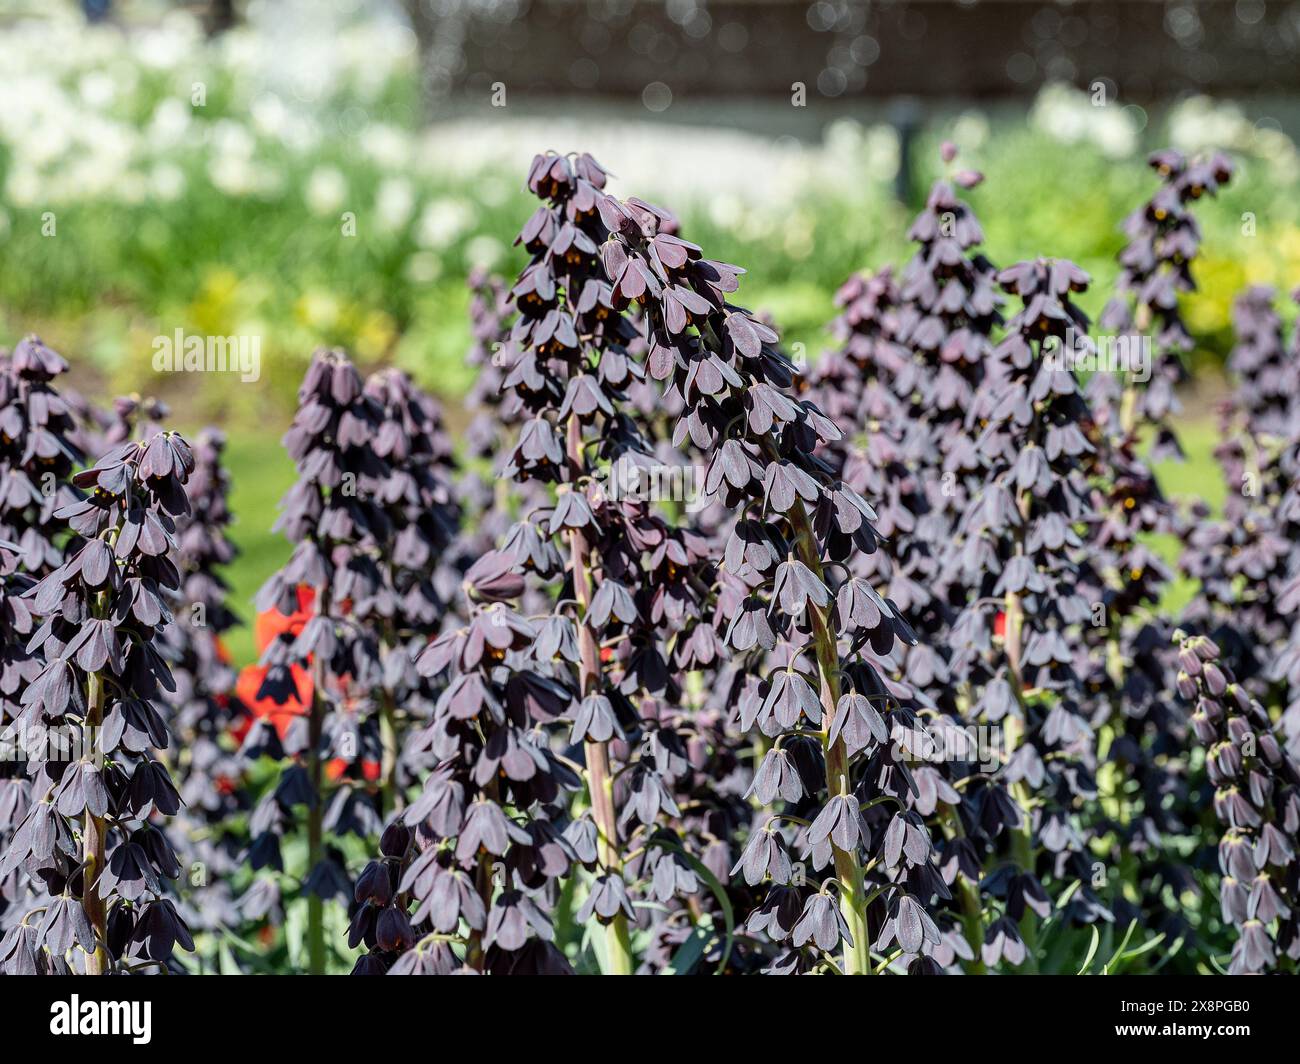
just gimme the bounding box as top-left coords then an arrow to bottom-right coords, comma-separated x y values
0,0 -> 1300,655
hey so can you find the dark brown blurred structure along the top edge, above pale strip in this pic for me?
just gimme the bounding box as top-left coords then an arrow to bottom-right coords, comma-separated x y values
404,0 -> 1300,101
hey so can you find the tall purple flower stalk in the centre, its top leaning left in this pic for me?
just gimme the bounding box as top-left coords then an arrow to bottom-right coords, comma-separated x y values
599,180 -> 943,974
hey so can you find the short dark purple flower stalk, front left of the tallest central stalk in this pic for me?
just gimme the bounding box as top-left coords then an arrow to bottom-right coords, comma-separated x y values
351,552 -> 579,974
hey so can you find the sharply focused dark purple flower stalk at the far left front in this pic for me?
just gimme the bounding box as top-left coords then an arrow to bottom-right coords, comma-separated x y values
5,432 -> 194,974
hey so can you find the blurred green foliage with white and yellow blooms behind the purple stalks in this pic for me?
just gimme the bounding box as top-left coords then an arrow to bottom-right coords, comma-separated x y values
0,9 -> 1300,418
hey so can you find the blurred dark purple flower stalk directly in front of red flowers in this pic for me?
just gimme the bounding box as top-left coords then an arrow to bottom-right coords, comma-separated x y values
244,351 -> 391,974
